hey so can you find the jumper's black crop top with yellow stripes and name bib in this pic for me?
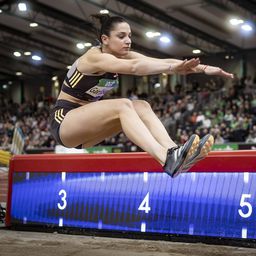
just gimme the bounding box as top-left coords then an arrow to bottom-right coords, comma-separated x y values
61,61 -> 118,101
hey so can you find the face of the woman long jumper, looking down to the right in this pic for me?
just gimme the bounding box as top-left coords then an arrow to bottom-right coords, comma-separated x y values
102,22 -> 131,57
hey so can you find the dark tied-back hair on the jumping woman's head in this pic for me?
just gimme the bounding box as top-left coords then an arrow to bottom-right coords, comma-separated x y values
91,14 -> 127,43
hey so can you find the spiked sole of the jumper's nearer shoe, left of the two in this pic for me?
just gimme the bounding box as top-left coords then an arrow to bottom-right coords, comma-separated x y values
170,134 -> 200,178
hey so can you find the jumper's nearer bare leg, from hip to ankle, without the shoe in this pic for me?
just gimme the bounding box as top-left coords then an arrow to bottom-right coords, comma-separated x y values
60,99 -> 167,165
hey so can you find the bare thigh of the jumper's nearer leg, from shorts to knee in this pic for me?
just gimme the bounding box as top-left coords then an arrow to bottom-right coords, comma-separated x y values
60,99 -> 124,147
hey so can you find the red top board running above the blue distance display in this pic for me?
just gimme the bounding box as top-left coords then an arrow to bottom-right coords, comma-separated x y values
10,150 -> 256,172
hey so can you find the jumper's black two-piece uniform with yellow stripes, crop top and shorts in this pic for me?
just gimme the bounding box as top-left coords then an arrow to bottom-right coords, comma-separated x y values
50,58 -> 119,148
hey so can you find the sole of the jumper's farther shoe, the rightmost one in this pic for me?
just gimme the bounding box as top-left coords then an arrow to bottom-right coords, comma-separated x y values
180,134 -> 214,173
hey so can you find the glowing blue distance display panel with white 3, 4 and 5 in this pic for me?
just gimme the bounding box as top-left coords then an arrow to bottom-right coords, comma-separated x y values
11,172 -> 256,239
